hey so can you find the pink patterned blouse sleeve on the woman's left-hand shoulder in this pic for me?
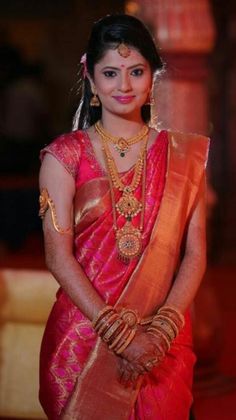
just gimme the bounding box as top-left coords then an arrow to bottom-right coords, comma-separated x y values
40,133 -> 81,178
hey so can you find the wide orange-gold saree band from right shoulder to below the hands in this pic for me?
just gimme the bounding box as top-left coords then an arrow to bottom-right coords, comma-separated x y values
60,132 -> 209,420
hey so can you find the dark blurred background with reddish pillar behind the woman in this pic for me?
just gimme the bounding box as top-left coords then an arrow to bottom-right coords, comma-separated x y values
0,0 -> 236,420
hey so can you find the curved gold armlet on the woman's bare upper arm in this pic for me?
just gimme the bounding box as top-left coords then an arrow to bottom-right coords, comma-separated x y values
39,188 -> 73,234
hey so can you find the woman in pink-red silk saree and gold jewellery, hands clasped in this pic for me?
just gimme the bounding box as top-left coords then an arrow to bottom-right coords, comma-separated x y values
40,15 -> 208,420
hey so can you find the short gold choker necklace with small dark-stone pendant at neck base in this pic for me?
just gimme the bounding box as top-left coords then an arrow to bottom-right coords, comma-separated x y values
94,121 -> 149,157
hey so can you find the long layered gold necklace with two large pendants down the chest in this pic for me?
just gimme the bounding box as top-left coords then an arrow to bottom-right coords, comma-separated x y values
95,123 -> 148,263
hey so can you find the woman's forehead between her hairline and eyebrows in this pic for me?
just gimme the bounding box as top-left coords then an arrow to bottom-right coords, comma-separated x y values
97,47 -> 148,67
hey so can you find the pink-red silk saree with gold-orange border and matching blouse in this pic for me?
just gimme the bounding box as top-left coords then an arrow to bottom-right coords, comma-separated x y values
40,131 -> 207,420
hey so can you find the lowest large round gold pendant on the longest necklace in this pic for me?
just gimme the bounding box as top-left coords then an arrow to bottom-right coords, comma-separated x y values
116,222 -> 142,263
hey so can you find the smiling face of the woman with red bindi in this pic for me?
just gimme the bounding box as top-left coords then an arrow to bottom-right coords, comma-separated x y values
93,48 -> 152,120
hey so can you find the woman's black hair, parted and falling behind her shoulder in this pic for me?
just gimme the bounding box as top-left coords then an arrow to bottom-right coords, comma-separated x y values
73,14 -> 163,129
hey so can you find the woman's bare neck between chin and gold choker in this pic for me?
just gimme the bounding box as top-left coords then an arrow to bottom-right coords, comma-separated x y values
101,113 -> 145,138
